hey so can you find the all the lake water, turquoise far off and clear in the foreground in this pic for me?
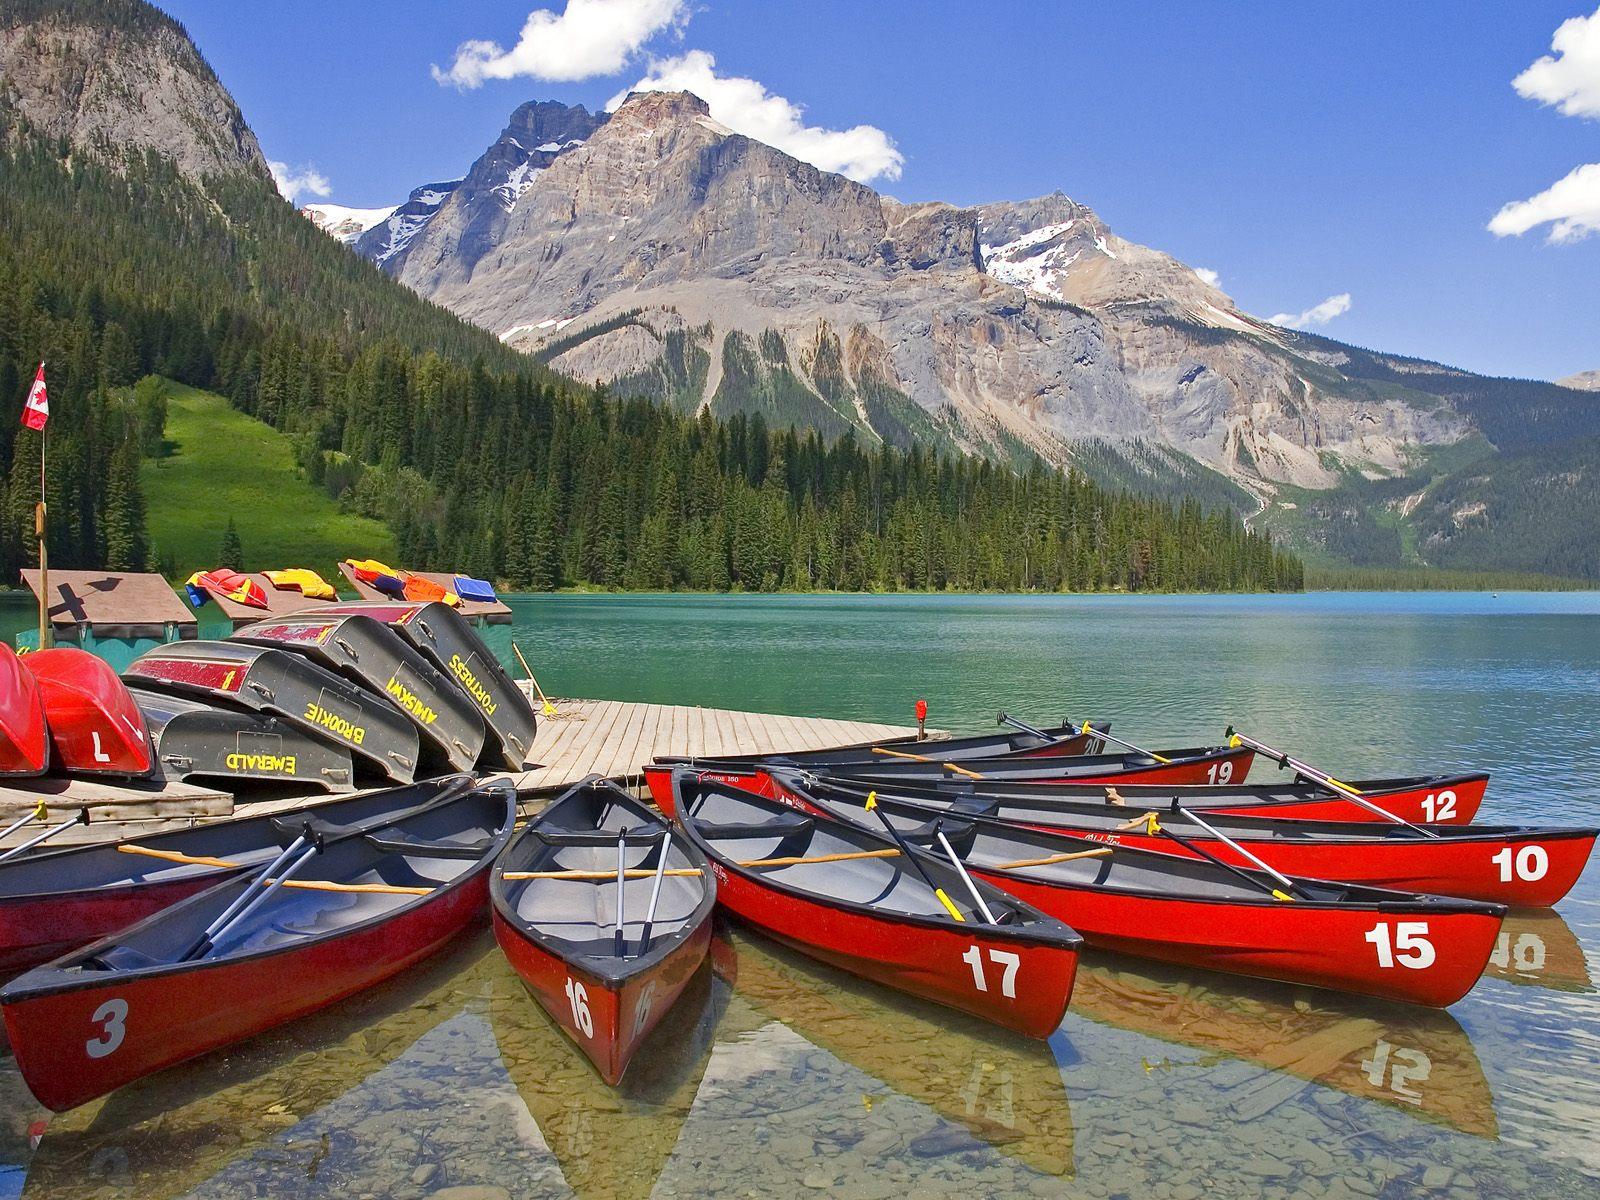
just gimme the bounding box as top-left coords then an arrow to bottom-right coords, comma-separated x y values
0,594 -> 1600,1200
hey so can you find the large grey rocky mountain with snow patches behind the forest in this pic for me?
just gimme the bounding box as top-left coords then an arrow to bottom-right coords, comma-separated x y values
357,93 -> 1470,494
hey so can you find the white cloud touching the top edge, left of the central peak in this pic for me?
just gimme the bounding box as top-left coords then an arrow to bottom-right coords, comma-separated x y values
434,0 -> 690,88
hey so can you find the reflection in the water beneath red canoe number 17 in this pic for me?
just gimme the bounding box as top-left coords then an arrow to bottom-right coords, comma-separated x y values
712,922 -> 1072,1176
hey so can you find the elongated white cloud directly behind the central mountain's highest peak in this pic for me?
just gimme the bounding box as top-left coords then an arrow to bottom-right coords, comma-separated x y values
606,50 -> 906,182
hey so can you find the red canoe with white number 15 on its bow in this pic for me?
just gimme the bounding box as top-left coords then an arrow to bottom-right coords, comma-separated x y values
766,774 -> 1506,1008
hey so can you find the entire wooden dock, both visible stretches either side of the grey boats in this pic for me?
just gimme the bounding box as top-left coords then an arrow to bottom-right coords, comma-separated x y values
0,699 -> 942,846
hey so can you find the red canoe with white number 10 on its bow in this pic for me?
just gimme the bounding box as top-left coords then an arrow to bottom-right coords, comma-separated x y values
771,770 -> 1600,909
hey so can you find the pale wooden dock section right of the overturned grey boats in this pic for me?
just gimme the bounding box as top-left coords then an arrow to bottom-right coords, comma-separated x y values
499,699 -> 917,789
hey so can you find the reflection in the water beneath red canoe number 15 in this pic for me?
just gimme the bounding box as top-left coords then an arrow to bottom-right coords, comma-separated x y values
1069,952 -> 1499,1138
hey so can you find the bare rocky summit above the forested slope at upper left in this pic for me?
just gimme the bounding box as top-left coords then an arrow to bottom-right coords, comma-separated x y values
0,0 -> 267,181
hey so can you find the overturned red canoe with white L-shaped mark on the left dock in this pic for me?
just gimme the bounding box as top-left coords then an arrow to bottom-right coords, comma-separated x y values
22,646 -> 155,776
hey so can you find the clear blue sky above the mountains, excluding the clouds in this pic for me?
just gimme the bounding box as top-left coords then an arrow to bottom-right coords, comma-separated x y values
160,0 -> 1600,378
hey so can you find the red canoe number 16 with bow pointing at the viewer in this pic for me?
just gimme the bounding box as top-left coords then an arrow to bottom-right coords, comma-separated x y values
490,779 -> 717,1085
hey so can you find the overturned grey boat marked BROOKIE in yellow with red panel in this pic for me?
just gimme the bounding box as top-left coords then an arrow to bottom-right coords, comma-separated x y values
123,642 -> 418,784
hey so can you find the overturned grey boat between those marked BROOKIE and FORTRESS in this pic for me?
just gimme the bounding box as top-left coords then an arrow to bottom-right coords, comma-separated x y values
229,610 -> 485,771
